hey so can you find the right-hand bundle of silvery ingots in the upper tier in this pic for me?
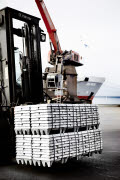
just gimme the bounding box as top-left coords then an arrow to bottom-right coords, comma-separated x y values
31,104 -> 99,134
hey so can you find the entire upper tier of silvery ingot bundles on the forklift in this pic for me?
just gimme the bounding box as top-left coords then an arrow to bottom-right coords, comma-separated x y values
15,104 -> 99,134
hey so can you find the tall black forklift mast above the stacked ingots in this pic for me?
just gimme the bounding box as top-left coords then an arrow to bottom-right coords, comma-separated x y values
0,7 -> 43,107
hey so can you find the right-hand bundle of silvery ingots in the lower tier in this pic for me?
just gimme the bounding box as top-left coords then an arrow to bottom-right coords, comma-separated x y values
32,129 -> 102,167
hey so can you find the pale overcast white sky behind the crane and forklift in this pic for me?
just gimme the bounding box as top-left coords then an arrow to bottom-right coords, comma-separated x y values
0,0 -> 120,96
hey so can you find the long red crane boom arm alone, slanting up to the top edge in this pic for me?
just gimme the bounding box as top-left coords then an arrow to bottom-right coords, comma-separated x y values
35,0 -> 62,53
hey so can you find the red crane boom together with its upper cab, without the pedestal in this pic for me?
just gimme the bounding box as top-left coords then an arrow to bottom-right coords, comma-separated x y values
35,0 -> 82,66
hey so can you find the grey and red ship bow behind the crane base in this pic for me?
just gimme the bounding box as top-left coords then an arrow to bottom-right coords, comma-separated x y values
77,76 -> 105,101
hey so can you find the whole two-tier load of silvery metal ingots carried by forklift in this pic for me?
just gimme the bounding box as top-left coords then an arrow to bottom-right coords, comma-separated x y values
15,104 -> 102,167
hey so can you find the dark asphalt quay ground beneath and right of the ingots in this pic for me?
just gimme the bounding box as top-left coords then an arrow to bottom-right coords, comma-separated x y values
0,107 -> 120,180
